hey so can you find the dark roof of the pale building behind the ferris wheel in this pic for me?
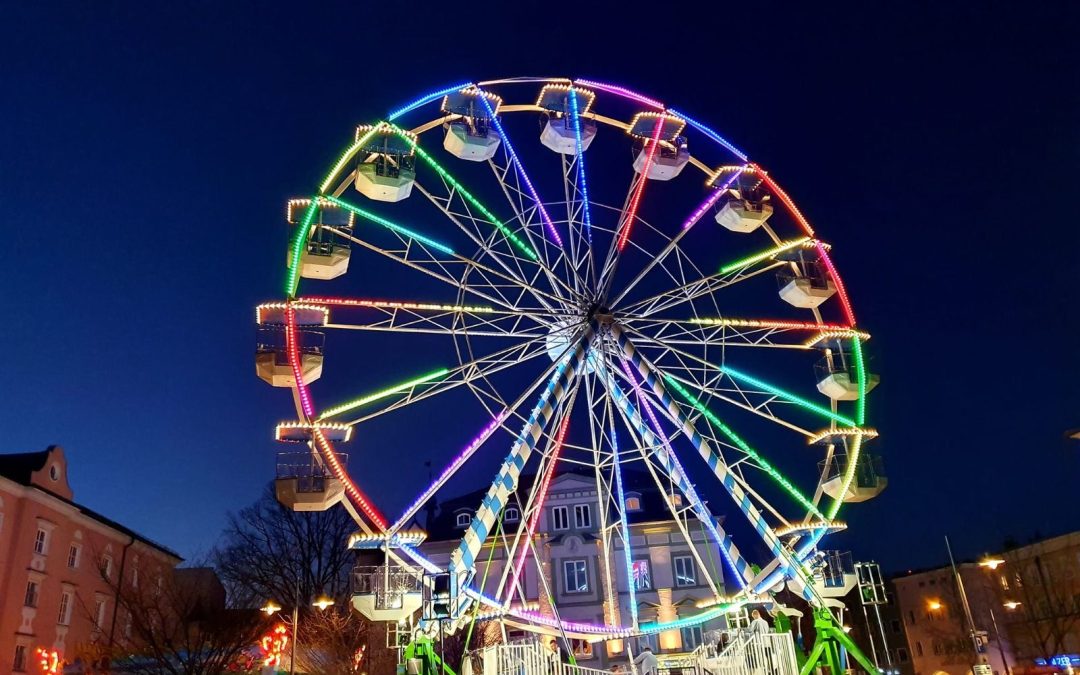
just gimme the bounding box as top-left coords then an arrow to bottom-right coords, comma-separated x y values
424,465 -> 708,541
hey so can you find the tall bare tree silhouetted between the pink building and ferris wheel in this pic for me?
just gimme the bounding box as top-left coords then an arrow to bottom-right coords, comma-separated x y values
211,485 -> 355,609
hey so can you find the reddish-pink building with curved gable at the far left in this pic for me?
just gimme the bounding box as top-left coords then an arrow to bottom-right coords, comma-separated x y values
0,446 -> 180,673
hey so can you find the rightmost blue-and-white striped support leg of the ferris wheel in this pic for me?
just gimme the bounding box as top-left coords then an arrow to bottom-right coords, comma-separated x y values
611,325 -> 816,603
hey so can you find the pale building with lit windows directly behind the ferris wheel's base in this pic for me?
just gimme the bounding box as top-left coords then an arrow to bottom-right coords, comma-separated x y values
421,469 -> 725,669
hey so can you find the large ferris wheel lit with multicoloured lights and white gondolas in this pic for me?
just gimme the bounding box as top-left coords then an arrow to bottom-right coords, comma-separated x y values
257,78 -> 886,640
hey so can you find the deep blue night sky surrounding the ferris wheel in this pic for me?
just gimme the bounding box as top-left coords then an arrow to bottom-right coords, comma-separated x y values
0,2 -> 1080,569
